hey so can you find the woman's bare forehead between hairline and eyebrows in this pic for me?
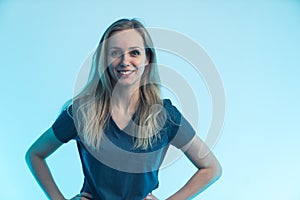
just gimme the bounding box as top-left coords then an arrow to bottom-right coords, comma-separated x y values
107,29 -> 144,49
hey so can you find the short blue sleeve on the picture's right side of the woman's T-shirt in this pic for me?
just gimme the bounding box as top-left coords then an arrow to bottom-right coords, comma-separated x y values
164,99 -> 196,149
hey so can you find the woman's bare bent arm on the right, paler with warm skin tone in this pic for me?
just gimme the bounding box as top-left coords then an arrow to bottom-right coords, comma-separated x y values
168,135 -> 222,200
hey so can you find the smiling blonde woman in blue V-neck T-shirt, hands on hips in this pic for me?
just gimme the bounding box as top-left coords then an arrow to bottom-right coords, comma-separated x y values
26,19 -> 221,200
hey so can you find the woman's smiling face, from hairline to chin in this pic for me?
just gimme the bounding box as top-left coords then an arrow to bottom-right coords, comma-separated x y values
107,29 -> 148,86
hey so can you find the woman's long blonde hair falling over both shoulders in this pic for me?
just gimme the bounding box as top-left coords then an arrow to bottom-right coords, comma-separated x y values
69,19 -> 166,149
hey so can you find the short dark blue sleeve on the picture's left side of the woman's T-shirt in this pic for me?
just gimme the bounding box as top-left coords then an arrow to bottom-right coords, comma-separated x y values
52,106 -> 77,143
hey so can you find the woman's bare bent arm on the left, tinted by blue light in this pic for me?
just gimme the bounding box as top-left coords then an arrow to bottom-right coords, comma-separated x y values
25,128 -> 65,200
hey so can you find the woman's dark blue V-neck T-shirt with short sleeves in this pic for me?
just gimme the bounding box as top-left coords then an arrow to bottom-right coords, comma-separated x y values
52,99 -> 195,200
